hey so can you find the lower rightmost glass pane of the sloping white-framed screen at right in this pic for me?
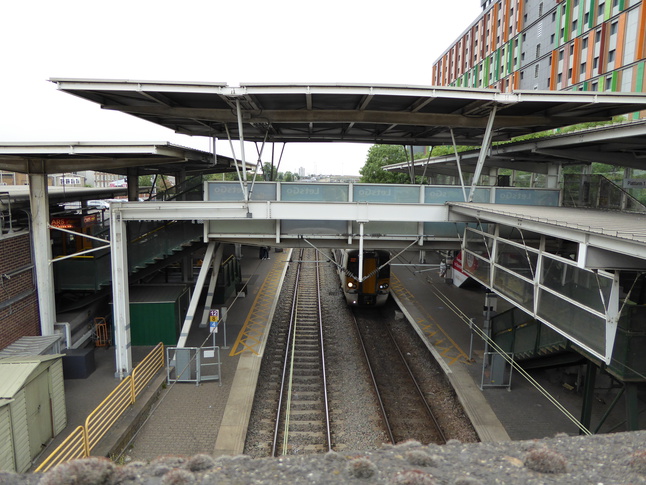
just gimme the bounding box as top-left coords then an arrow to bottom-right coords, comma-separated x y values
538,290 -> 606,355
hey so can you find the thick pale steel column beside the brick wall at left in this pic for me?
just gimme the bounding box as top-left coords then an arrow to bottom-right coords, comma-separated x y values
29,170 -> 56,335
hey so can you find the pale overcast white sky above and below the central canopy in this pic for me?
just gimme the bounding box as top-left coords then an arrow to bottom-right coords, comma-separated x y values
0,0 -> 480,175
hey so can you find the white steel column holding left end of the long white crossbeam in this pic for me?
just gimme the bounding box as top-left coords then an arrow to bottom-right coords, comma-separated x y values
110,207 -> 132,379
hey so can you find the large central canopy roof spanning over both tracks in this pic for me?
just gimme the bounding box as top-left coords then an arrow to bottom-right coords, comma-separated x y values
51,78 -> 646,145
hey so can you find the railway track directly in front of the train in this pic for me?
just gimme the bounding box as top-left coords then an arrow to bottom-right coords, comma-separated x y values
354,310 -> 446,444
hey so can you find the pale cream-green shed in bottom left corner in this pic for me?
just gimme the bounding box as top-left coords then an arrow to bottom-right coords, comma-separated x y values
0,354 -> 67,473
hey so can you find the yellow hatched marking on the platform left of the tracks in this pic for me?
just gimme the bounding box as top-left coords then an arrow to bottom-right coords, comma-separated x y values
229,252 -> 289,357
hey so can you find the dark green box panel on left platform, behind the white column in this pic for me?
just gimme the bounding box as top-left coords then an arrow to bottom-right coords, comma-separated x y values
130,302 -> 180,345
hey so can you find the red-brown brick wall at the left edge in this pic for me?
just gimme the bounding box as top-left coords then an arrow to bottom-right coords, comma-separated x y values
0,232 -> 40,349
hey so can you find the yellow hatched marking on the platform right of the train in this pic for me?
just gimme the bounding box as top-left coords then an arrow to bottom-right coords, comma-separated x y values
390,273 -> 471,365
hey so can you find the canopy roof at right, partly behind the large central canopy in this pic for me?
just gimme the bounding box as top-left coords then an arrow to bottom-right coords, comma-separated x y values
383,120 -> 646,175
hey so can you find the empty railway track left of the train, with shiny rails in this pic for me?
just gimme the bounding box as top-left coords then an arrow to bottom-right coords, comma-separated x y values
271,249 -> 332,456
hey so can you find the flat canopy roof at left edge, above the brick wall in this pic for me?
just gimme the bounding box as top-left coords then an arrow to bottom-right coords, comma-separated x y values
0,142 -> 248,176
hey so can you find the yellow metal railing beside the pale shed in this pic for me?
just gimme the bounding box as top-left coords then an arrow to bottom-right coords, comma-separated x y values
35,343 -> 165,472
